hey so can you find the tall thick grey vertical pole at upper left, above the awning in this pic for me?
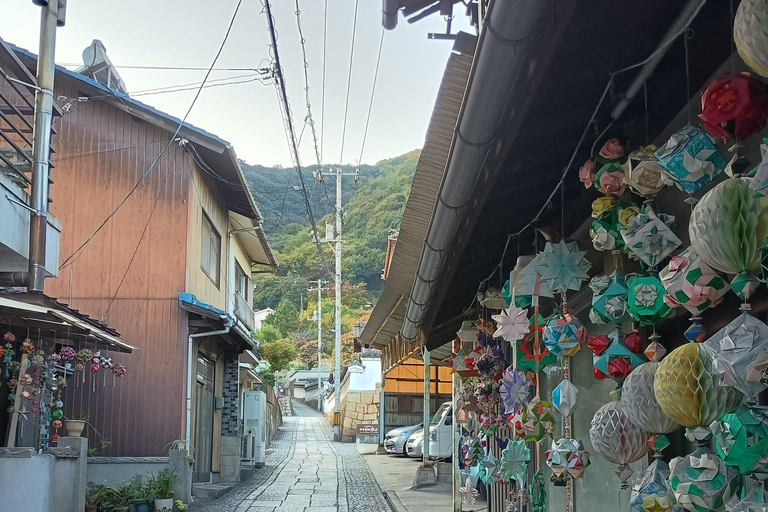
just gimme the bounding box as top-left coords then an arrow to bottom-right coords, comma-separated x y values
27,1 -> 59,293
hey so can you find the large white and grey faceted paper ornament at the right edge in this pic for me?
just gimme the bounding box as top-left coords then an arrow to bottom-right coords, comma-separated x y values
704,313 -> 768,399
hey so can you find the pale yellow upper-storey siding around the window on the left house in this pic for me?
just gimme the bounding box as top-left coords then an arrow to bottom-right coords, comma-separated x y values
186,164 -> 230,309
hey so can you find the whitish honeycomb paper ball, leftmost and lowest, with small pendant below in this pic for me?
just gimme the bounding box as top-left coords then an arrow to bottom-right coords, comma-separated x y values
589,400 -> 648,489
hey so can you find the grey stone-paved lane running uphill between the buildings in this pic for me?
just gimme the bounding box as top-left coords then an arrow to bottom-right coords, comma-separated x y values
189,404 -> 391,512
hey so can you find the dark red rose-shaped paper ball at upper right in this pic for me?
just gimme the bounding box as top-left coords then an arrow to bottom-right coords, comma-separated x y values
699,73 -> 768,141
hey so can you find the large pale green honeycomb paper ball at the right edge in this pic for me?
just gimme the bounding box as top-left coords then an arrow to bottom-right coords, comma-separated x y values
688,178 -> 768,288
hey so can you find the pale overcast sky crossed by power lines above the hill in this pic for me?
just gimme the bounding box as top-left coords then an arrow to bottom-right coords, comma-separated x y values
0,0 -> 472,167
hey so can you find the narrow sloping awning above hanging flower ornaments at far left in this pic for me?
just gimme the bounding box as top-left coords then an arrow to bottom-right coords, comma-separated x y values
0,292 -> 141,352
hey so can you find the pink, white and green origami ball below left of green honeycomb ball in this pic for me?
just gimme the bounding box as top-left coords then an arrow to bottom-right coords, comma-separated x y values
659,248 -> 728,315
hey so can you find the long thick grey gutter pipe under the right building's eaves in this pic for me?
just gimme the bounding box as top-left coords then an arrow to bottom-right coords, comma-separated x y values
400,0 -> 552,340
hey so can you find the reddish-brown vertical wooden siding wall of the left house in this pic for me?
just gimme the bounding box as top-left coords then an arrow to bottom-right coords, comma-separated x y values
46,80 -> 190,456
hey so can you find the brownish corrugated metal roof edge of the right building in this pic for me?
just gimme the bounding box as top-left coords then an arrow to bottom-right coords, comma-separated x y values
360,53 -> 472,354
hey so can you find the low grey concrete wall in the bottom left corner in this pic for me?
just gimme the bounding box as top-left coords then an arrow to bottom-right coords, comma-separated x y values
0,437 -> 88,512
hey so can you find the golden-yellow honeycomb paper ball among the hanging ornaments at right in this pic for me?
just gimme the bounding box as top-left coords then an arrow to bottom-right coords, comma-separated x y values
653,343 -> 743,427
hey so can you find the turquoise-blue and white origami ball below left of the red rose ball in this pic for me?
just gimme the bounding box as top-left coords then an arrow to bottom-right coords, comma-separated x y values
656,125 -> 726,194
